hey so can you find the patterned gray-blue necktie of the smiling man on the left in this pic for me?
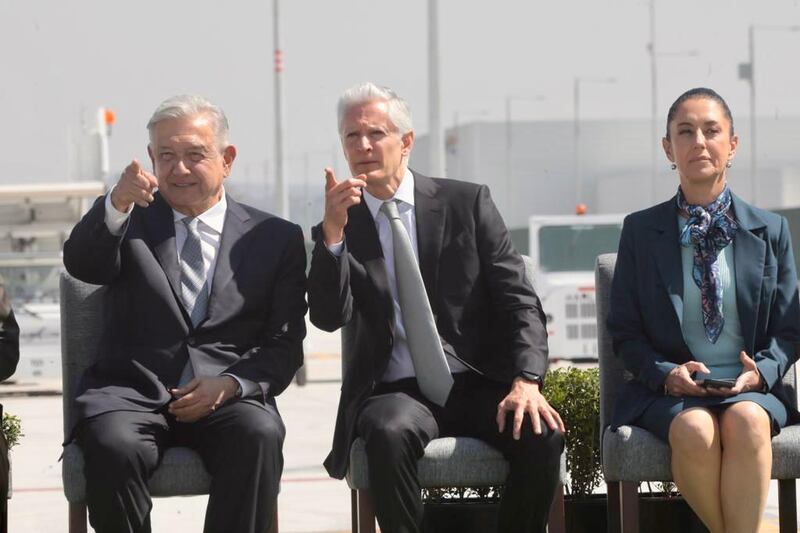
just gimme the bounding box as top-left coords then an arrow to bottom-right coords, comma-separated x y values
178,217 -> 208,387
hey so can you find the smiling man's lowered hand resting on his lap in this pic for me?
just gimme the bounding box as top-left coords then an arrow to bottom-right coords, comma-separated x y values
169,376 -> 239,422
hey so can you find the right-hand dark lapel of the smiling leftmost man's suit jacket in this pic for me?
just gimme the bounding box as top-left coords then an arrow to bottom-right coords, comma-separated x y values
208,195 -> 250,319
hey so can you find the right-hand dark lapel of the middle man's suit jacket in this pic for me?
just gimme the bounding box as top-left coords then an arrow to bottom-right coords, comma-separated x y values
414,172 -> 446,308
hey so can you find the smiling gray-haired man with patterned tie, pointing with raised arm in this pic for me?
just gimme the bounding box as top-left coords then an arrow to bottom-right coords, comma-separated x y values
64,96 -> 306,533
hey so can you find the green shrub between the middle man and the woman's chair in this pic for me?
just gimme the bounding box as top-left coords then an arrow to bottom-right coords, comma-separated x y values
544,367 -> 603,496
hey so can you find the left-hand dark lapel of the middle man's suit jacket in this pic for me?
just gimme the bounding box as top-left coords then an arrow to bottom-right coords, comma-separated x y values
345,198 -> 394,316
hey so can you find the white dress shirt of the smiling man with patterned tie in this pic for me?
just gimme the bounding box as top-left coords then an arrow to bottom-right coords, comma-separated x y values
105,189 -> 259,397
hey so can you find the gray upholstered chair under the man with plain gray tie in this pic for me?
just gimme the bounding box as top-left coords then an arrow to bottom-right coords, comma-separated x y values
342,256 -> 566,533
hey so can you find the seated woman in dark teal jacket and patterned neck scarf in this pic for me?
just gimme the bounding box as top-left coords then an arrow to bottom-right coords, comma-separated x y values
608,88 -> 800,533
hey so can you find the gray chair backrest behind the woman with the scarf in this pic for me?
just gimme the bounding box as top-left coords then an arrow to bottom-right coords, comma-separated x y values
595,254 -> 797,428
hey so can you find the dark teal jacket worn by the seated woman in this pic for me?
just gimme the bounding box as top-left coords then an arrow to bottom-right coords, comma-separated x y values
608,195 -> 800,427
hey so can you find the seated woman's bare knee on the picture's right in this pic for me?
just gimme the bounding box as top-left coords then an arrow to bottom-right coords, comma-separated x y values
719,401 -> 772,452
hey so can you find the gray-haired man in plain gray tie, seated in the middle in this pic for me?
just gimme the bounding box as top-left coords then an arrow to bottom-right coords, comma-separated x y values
308,83 -> 564,533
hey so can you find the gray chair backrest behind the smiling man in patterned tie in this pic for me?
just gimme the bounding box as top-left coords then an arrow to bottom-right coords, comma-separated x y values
60,272 -> 107,437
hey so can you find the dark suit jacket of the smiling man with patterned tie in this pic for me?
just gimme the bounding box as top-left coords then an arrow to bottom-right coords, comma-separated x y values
64,193 -> 306,432
